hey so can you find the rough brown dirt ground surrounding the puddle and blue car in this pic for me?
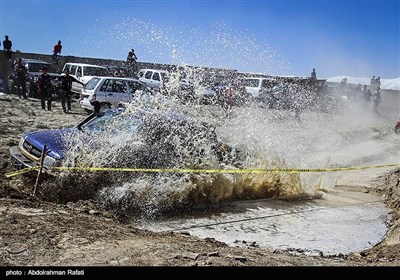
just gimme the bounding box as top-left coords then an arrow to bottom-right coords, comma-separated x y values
0,94 -> 400,267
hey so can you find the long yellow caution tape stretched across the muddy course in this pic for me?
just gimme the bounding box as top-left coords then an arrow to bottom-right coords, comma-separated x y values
5,163 -> 400,177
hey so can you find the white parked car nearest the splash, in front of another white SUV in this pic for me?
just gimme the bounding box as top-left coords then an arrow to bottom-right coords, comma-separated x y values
79,77 -> 149,112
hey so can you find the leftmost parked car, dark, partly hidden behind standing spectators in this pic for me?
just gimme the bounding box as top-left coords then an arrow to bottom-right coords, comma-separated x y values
8,58 -> 60,97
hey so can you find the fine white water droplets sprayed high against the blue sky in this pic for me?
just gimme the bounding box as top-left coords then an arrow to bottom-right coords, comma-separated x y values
87,17 -> 291,75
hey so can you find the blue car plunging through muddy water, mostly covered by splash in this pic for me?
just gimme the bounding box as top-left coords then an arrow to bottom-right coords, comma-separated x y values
10,102 -> 241,169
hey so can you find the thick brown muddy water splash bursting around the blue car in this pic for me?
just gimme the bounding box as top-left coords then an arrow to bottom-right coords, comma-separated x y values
48,98 -> 301,218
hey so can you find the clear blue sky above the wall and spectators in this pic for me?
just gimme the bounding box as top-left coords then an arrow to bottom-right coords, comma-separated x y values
0,0 -> 400,79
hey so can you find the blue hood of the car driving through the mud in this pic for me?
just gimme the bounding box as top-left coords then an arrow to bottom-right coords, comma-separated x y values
24,128 -> 81,159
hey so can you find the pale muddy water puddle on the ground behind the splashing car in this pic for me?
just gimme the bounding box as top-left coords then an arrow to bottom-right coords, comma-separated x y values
139,191 -> 390,255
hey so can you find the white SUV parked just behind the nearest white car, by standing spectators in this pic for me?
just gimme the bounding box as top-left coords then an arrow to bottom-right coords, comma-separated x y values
62,62 -> 111,95
